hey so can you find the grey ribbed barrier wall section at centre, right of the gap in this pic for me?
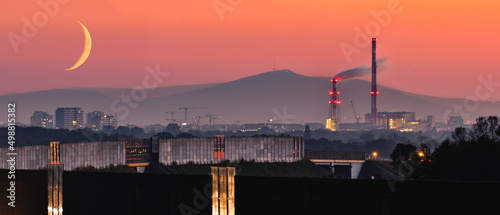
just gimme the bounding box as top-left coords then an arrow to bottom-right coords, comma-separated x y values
159,137 -> 304,165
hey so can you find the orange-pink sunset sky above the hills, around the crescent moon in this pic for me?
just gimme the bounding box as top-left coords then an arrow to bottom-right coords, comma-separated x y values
0,0 -> 500,101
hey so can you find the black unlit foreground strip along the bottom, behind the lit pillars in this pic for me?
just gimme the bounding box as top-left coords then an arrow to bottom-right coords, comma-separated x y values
0,170 -> 500,215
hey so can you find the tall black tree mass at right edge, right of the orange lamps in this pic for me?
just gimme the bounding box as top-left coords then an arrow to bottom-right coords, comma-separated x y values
412,116 -> 500,181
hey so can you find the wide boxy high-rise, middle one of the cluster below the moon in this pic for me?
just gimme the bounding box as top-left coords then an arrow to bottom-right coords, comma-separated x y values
56,107 -> 83,130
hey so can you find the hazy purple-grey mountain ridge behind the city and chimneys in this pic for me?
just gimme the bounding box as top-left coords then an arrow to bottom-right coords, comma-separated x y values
0,70 -> 500,125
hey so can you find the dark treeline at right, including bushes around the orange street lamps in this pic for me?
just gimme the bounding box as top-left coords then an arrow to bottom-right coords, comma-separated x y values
391,116 -> 500,181
